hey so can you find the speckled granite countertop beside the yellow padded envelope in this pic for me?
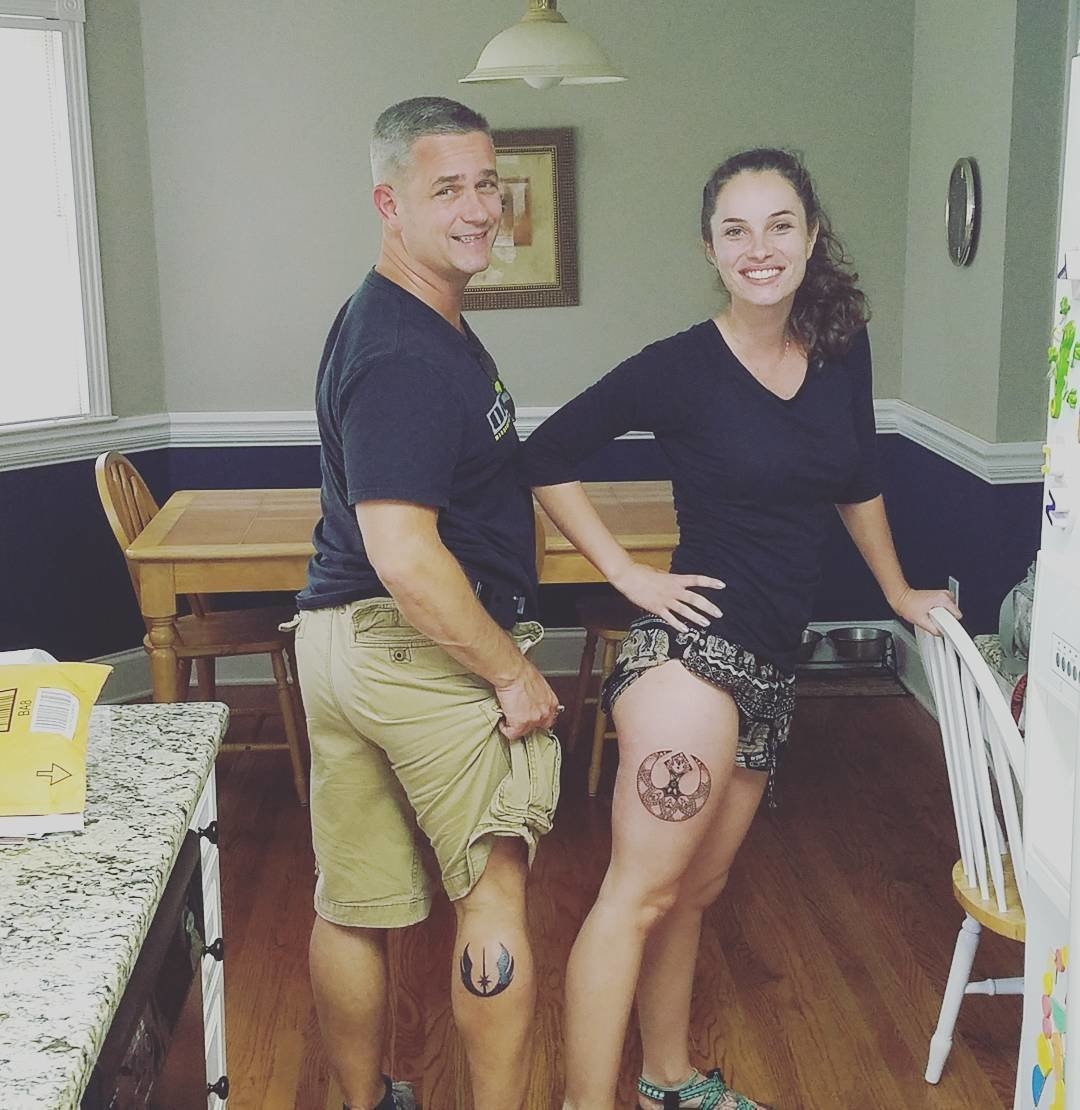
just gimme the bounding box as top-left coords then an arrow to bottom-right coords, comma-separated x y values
0,703 -> 229,1110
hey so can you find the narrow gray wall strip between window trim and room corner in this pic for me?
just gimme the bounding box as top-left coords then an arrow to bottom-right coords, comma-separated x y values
85,0 -> 165,416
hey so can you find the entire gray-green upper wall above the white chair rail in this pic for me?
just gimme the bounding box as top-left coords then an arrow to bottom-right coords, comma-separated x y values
87,0 -> 1074,441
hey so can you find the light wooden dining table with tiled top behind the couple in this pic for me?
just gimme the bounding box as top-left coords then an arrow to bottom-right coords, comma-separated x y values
127,482 -> 678,702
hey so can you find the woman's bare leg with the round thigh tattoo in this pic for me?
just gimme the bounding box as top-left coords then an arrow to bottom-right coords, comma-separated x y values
565,660 -> 738,1110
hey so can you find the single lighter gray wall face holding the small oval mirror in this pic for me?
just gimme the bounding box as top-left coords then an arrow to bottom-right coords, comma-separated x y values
900,0 -> 1016,440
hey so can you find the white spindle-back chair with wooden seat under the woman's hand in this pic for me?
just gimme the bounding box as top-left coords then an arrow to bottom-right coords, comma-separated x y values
916,608 -> 1026,1083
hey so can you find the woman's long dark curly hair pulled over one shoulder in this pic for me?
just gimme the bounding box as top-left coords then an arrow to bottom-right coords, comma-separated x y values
702,147 -> 870,360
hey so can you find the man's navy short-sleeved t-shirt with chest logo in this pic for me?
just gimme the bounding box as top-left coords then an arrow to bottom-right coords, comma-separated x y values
297,270 -> 536,625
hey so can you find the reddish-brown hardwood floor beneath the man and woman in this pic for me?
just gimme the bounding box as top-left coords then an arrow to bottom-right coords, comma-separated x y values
208,688 -> 1023,1110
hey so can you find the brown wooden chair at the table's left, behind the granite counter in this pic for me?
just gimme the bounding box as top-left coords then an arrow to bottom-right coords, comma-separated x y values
94,451 -> 307,806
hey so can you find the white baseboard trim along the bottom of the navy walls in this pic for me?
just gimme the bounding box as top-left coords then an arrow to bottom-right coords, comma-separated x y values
92,620 -> 937,717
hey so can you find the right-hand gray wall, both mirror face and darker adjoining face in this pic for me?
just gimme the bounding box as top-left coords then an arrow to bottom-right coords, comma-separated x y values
900,0 -> 1069,442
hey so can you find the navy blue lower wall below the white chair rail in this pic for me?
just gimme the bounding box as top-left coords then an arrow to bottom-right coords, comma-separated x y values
0,435 -> 1041,659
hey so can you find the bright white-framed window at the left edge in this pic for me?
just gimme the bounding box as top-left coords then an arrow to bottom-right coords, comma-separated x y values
0,0 -> 110,430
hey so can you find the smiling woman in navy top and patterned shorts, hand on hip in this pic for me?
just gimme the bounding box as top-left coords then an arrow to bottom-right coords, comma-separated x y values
524,150 -> 958,1110
